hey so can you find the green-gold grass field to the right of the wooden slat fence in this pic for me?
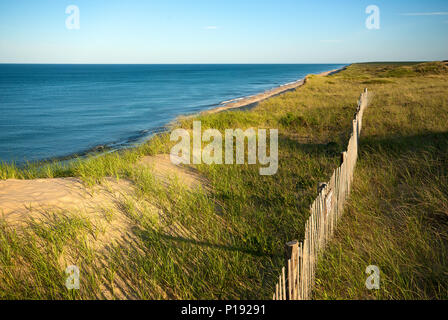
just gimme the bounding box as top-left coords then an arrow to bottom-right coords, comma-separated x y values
316,63 -> 448,299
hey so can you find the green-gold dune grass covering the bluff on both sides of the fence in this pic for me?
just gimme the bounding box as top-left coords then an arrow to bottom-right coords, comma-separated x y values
0,63 -> 448,299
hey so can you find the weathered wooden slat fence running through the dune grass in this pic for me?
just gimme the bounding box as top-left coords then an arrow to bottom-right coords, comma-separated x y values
272,89 -> 368,300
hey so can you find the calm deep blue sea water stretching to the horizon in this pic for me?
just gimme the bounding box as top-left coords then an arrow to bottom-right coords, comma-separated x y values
0,64 -> 342,163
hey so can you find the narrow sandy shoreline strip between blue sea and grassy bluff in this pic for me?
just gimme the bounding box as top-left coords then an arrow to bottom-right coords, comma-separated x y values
6,65 -> 350,168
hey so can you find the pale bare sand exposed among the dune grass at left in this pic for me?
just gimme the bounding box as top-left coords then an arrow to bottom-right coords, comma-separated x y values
0,155 -> 205,260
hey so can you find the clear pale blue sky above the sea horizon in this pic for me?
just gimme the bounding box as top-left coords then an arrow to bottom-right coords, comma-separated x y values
0,0 -> 448,63
